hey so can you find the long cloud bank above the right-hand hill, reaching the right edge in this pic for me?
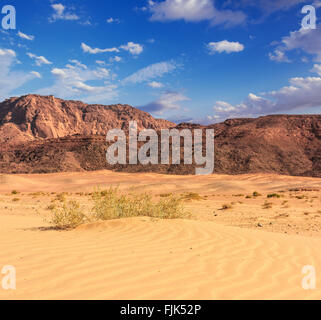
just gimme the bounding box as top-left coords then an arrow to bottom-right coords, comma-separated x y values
209,64 -> 321,119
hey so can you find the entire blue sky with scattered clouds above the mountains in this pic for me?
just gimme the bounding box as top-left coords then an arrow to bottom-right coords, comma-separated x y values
0,0 -> 321,123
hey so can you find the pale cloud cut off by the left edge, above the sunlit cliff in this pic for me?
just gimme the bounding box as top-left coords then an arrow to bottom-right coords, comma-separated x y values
0,48 -> 41,100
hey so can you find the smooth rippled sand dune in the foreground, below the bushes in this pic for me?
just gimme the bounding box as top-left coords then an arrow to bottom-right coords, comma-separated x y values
0,216 -> 321,299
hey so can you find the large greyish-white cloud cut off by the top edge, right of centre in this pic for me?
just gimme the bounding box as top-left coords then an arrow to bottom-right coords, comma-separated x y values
148,0 -> 246,26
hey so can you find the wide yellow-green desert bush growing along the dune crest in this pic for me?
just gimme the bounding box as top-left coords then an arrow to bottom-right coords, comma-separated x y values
93,188 -> 186,220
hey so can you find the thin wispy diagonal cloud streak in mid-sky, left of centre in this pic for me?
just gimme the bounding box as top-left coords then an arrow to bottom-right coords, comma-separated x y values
123,61 -> 178,84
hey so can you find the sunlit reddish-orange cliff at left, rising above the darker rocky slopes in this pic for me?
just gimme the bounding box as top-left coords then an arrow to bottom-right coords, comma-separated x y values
0,95 -> 174,145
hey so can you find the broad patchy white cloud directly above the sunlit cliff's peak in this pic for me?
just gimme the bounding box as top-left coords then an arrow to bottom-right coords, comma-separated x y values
38,60 -> 117,103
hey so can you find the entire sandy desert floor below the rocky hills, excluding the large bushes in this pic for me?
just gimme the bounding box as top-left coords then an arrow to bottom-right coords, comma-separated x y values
0,171 -> 321,299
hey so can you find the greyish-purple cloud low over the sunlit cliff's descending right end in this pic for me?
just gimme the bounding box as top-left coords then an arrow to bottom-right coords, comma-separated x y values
140,91 -> 190,115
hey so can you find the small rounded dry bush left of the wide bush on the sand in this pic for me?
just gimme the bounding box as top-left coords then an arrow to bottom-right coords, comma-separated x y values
47,200 -> 88,230
